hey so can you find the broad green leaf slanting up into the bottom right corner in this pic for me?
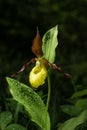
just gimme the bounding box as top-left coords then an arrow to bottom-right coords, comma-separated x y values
58,110 -> 87,130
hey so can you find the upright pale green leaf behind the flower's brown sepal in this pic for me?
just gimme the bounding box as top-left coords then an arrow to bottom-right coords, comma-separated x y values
42,25 -> 58,63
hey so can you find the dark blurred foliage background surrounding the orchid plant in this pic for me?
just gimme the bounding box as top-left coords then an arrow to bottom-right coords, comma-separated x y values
0,0 -> 87,130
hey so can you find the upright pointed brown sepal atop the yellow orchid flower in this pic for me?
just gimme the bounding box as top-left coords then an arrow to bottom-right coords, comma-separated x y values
32,28 -> 43,57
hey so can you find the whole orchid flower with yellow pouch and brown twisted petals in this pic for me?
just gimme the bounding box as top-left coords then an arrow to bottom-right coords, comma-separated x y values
12,29 -> 71,89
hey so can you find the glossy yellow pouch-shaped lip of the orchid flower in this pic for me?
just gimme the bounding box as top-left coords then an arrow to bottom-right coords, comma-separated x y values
29,65 -> 47,88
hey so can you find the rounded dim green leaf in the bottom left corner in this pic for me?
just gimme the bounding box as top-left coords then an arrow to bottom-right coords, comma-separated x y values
0,111 -> 12,130
